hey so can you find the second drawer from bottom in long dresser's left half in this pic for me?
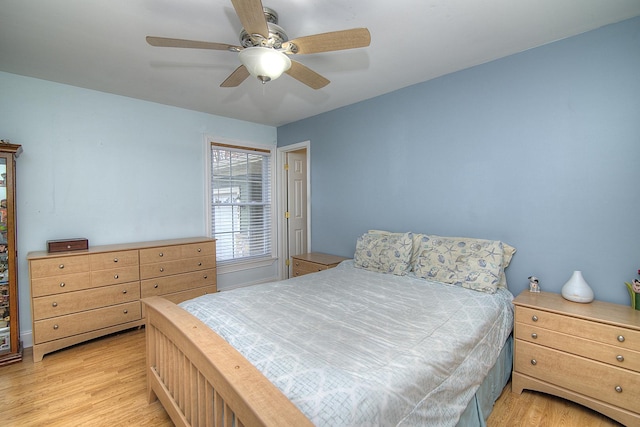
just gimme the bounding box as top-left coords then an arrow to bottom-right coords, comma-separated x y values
33,282 -> 140,320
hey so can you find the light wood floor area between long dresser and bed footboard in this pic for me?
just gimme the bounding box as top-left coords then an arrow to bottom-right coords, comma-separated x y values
0,329 -> 173,427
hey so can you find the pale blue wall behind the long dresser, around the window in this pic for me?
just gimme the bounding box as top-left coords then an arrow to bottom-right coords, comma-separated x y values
0,73 -> 276,346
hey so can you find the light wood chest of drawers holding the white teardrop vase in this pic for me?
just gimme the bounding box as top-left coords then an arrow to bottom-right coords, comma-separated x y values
512,291 -> 640,426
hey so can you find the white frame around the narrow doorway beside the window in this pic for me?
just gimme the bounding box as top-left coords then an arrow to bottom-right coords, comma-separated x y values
276,141 -> 311,279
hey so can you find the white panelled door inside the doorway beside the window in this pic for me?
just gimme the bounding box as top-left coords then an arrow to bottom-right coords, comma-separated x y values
286,150 -> 307,277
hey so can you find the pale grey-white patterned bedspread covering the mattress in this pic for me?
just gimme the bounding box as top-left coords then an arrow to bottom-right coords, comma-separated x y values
180,261 -> 513,426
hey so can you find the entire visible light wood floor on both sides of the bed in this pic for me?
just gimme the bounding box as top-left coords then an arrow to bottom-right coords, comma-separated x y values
0,329 -> 620,427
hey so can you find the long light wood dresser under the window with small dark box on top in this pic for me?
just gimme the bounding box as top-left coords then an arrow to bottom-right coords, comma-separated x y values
27,237 -> 216,361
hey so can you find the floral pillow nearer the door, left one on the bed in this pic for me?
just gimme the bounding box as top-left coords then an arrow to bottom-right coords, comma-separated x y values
353,233 -> 413,276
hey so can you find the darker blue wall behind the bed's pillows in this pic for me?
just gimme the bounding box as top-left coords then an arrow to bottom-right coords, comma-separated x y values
278,18 -> 640,304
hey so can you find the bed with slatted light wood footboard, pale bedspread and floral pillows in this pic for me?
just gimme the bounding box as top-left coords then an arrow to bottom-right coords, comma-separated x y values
143,232 -> 515,426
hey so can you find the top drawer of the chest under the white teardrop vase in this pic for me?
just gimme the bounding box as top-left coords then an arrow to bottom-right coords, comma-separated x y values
515,307 -> 640,351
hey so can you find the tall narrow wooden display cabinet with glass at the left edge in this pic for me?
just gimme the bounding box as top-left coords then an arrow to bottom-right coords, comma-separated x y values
0,140 -> 22,366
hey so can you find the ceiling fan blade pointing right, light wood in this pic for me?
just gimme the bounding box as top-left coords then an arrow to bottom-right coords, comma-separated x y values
282,28 -> 371,54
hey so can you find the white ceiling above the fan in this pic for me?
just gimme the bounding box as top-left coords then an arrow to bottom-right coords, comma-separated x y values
0,0 -> 640,126
